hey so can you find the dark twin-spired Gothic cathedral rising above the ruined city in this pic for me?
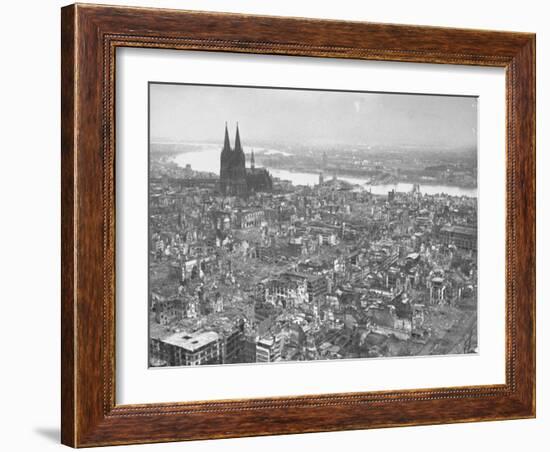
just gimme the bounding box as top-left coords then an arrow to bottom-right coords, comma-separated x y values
220,123 -> 273,197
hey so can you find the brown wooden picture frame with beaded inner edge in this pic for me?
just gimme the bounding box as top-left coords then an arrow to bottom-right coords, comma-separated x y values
61,4 -> 535,447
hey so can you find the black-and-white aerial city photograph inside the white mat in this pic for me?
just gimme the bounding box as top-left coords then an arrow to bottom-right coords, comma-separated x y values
148,82 -> 478,367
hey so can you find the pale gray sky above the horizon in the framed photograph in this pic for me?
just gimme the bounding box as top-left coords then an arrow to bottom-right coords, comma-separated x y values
150,84 -> 477,149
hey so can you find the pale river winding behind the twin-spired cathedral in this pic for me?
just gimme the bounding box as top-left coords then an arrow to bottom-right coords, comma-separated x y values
174,145 -> 477,198
